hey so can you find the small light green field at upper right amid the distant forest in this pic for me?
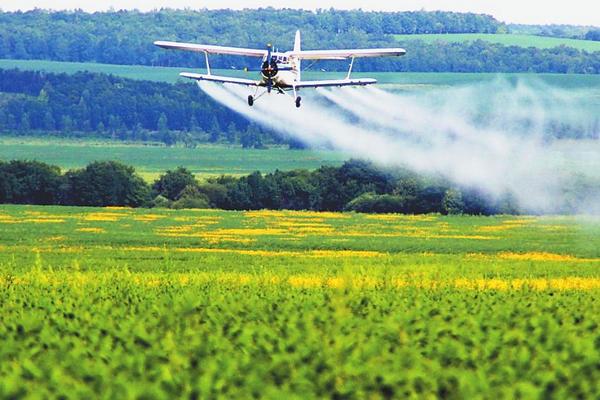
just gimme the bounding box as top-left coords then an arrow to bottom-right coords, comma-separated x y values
394,33 -> 600,52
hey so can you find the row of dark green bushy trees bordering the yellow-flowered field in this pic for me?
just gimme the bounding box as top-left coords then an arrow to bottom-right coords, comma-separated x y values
0,160 -> 528,214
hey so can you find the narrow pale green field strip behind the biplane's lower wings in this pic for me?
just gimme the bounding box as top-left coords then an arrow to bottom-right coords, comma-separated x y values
0,60 -> 600,89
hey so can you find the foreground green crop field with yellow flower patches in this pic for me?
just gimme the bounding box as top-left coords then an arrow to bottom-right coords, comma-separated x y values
0,206 -> 600,398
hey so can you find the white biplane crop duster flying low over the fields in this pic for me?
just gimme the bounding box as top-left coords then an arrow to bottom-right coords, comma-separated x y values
154,31 -> 406,107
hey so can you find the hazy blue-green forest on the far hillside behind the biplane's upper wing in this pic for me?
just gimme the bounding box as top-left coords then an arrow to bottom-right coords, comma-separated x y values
0,9 -> 600,74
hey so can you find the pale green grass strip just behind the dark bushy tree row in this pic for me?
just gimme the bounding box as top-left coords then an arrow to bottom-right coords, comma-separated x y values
0,137 -> 347,180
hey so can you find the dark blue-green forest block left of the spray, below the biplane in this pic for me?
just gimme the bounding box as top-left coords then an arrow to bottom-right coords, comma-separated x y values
0,69 -> 282,147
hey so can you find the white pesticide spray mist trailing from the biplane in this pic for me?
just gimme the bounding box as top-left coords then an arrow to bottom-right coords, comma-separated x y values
199,80 -> 600,216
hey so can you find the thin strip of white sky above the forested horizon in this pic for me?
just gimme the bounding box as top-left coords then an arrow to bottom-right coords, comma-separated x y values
0,0 -> 600,26
